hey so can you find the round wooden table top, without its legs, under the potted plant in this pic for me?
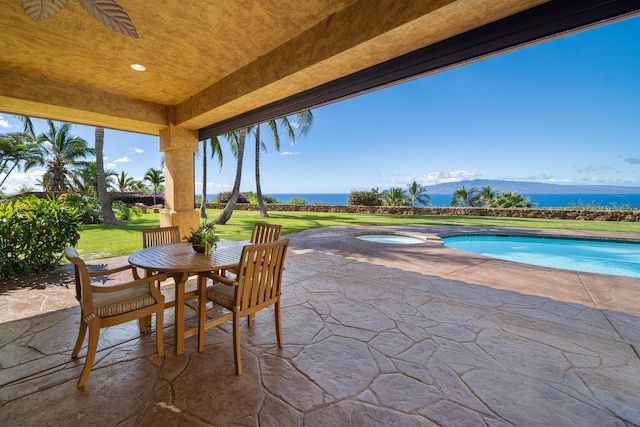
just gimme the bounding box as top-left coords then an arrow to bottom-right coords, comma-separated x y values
129,240 -> 248,273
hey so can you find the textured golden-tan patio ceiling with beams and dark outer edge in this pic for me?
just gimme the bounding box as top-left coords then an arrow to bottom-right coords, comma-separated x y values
0,0 -> 640,139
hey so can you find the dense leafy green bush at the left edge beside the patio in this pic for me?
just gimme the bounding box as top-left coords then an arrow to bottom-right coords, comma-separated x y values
0,196 -> 81,276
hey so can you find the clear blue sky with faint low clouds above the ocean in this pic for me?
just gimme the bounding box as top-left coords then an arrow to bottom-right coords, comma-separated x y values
0,17 -> 640,195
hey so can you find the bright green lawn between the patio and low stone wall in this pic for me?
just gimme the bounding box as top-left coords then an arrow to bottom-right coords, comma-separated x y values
78,210 -> 640,259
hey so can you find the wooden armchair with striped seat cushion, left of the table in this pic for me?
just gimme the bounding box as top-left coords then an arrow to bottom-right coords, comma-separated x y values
64,247 -> 166,388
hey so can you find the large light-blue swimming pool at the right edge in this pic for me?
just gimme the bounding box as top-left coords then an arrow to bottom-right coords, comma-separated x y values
442,235 -> 640,277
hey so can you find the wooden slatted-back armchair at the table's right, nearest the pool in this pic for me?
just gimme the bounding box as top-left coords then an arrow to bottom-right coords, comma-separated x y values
198,239 -> 289,375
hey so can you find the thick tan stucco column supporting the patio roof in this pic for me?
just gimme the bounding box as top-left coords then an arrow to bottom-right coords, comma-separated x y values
160,126 -> 199,236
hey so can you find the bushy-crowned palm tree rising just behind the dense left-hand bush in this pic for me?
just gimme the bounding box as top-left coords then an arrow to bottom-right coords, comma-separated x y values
37,120 -> 95,192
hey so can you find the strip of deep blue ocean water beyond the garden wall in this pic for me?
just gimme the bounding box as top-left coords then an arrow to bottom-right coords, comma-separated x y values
262,193 -> 640,209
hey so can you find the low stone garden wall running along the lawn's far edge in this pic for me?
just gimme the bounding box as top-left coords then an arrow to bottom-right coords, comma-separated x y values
207,203 -> 640,222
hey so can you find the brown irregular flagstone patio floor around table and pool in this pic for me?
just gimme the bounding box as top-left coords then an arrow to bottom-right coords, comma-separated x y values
0,226 -> 640,427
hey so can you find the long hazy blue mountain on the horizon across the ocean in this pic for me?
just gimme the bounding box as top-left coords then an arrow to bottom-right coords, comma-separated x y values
427,179 -> 640,194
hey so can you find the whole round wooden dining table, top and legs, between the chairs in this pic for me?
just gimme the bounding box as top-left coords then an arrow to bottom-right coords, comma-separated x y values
129,240 -> 249,355
